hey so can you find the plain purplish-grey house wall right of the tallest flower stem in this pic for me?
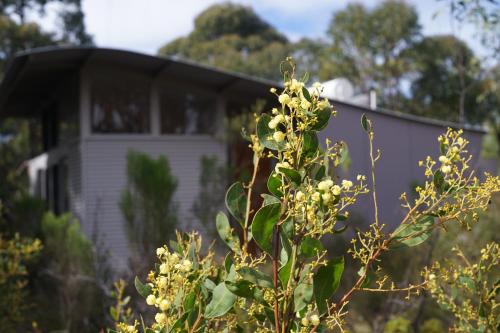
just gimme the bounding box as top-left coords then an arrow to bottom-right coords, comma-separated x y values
320,103 -> 494,226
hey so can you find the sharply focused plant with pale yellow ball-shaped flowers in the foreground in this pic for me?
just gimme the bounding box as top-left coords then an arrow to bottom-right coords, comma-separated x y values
112,59 -> 500,333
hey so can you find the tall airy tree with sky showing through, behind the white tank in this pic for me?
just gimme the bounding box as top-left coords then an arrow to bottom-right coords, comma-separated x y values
322,1 -> 420,109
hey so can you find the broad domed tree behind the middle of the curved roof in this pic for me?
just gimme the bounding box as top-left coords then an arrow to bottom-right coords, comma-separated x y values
158,3 -> 290,79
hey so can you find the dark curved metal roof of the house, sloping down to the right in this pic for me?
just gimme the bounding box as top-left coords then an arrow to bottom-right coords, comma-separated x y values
0,47 -> 484,132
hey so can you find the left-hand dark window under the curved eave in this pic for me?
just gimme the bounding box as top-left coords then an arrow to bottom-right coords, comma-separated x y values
91,75 -> 150,133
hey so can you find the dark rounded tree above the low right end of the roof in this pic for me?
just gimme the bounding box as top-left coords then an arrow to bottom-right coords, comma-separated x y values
405,35 -> 484,123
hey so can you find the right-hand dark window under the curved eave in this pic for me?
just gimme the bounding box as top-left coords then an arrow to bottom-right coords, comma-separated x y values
160,89 -> 216,134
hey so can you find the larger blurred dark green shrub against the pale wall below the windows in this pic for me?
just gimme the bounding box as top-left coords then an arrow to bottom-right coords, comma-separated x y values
120,151 -> 177,257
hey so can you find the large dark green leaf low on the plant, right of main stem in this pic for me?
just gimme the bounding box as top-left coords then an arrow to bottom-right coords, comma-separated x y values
313,257 -> 344,314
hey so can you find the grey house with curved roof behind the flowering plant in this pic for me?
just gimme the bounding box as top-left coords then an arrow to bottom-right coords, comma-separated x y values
0,47 -> 488,267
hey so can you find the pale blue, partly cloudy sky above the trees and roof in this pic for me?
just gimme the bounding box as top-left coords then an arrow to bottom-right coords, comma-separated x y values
38,0 -> 483,54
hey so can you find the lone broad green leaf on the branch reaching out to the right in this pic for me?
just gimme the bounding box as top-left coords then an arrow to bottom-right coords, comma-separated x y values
390,215 -> 434,248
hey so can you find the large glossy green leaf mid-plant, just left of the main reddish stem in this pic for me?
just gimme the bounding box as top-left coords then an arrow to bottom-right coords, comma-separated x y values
251,203 -> 281,253
